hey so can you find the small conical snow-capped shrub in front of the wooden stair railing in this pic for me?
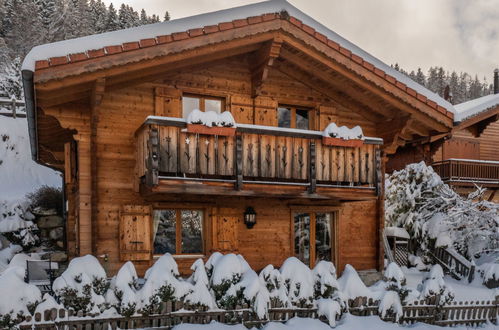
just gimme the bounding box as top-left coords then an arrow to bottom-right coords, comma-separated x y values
418,265 -> 454,306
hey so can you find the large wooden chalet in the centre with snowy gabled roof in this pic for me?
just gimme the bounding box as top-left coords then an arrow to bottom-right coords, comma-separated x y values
23,1 -> 454,273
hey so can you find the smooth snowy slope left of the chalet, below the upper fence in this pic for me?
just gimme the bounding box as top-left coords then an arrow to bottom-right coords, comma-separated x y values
0,116 -> 62,199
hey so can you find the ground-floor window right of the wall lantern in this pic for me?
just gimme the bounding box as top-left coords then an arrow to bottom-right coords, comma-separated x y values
293,211 -> 338,267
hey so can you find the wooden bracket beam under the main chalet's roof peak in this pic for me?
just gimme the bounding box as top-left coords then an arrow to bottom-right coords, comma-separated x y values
248,38 -> 282,97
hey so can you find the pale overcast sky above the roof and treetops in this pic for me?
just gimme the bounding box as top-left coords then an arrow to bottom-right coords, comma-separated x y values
104,0 -> 499,83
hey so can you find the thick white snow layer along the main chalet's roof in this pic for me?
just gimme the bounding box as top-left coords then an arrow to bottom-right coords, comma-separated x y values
22,0 -> 454,113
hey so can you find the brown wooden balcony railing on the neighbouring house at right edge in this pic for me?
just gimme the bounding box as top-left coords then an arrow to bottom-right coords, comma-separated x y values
432,159 -> 499,185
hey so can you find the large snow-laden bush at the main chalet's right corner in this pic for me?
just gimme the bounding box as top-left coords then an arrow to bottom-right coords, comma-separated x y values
385,162 -> 499,258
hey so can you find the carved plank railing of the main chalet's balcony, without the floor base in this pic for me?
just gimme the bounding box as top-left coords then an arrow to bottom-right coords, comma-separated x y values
136,117 -> 383,197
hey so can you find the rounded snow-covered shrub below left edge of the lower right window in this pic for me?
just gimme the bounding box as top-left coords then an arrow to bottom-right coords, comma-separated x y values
280,257 -> 315,307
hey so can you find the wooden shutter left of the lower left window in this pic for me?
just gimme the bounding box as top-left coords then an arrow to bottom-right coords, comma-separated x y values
120,205 -> 152,261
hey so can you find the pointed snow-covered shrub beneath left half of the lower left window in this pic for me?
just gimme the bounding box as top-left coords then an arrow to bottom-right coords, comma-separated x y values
137,253 -> 192,315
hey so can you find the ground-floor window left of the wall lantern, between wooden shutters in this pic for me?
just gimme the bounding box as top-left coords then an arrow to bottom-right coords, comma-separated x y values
153,209 -> 204,254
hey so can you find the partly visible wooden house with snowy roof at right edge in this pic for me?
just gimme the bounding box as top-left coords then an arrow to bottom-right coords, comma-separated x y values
432,77 -> 499,202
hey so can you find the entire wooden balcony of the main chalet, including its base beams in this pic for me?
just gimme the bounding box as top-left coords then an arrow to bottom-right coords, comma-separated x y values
135,117 -> 383,200
